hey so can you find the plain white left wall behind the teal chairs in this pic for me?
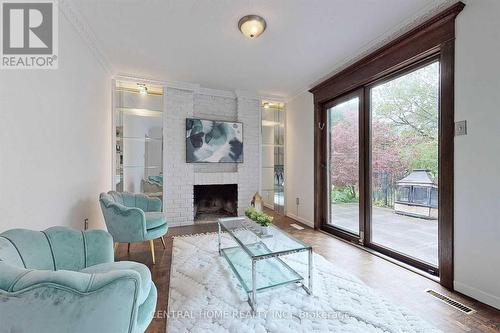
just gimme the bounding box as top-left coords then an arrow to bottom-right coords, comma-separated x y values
0,15 -> 111,232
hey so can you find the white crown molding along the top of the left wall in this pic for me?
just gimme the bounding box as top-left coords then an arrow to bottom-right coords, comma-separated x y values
58,0 -> 114,75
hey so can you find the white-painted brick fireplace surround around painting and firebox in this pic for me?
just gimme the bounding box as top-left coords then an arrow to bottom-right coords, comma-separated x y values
164,87 -> 260,226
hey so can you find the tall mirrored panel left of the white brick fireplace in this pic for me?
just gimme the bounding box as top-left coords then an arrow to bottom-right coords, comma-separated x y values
114,81 -> 163,200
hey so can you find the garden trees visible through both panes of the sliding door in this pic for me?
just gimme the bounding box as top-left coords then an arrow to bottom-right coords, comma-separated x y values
330,62 -> 439,204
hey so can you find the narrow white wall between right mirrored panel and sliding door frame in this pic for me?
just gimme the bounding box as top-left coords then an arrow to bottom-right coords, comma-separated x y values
285,92 -> 314,227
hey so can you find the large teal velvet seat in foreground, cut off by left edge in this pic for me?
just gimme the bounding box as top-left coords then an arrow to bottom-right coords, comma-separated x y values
0,227 -> 157,333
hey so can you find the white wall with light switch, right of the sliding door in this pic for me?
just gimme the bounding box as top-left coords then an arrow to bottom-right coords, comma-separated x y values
455,0 -> 500,308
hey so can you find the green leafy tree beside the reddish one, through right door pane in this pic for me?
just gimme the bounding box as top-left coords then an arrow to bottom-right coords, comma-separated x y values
371,62 -> 439,179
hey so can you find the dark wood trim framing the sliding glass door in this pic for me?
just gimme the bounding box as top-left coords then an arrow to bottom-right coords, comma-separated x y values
310,2 -> 465,289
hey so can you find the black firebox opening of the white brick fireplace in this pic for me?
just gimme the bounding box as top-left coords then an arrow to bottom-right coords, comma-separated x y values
193,184 -> 238,223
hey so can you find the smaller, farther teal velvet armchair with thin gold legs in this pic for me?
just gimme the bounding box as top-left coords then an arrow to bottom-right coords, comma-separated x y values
99,191 -> 168,264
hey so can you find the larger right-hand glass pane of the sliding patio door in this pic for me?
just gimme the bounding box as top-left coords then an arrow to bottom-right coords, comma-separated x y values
369,60 -> 440,268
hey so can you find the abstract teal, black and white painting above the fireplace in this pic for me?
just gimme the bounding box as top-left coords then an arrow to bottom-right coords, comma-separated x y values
186,118 -> 243,163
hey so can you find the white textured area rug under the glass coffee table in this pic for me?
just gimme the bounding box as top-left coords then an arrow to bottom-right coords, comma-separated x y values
167,233 -> 440,333
